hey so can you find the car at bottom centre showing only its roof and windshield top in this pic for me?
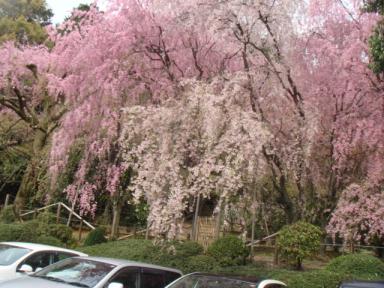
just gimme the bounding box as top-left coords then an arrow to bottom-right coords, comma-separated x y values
165,273 -> 286,288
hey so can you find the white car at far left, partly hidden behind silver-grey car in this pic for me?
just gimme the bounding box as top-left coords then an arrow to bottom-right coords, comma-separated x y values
0,242 -> 87,282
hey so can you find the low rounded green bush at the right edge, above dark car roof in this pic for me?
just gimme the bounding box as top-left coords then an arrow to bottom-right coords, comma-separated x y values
325,254 -> 384,280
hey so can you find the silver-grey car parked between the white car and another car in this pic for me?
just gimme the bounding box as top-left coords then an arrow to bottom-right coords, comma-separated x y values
0,257 -> 182,288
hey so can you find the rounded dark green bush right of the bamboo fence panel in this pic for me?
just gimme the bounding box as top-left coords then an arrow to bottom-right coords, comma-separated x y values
207,235 -> 249,266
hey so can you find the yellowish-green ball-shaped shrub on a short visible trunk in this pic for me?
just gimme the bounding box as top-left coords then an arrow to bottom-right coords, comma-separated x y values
277,222 -> 322,270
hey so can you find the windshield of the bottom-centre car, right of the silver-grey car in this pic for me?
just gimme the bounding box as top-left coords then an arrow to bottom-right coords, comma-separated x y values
167,274 -> 256,288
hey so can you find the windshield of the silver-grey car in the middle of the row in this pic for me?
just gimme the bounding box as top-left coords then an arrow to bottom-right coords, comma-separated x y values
32,258 -> 116,287
